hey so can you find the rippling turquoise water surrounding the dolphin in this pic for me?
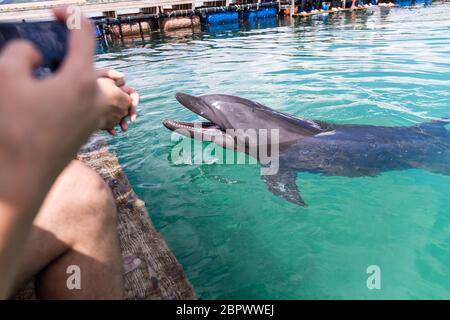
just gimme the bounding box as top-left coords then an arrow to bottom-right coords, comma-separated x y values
98,4 -> 450,299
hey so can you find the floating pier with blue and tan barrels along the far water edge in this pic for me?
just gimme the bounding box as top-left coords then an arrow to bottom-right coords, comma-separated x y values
0,0 -> 380,43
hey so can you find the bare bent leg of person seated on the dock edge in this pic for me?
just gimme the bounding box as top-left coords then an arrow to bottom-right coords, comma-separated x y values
11,161 -> 123,299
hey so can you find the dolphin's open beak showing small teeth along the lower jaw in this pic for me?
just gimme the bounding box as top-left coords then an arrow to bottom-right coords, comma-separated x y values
162,93 -> 225,141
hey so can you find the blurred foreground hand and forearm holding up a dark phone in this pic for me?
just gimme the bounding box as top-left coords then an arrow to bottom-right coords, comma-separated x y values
0,8 -> 104,204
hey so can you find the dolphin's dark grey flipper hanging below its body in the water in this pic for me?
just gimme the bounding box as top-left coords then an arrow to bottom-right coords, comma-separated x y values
261,171 -> 306,206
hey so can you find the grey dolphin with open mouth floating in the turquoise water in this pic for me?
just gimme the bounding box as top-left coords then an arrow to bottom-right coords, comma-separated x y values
163,93 -> 450,206
